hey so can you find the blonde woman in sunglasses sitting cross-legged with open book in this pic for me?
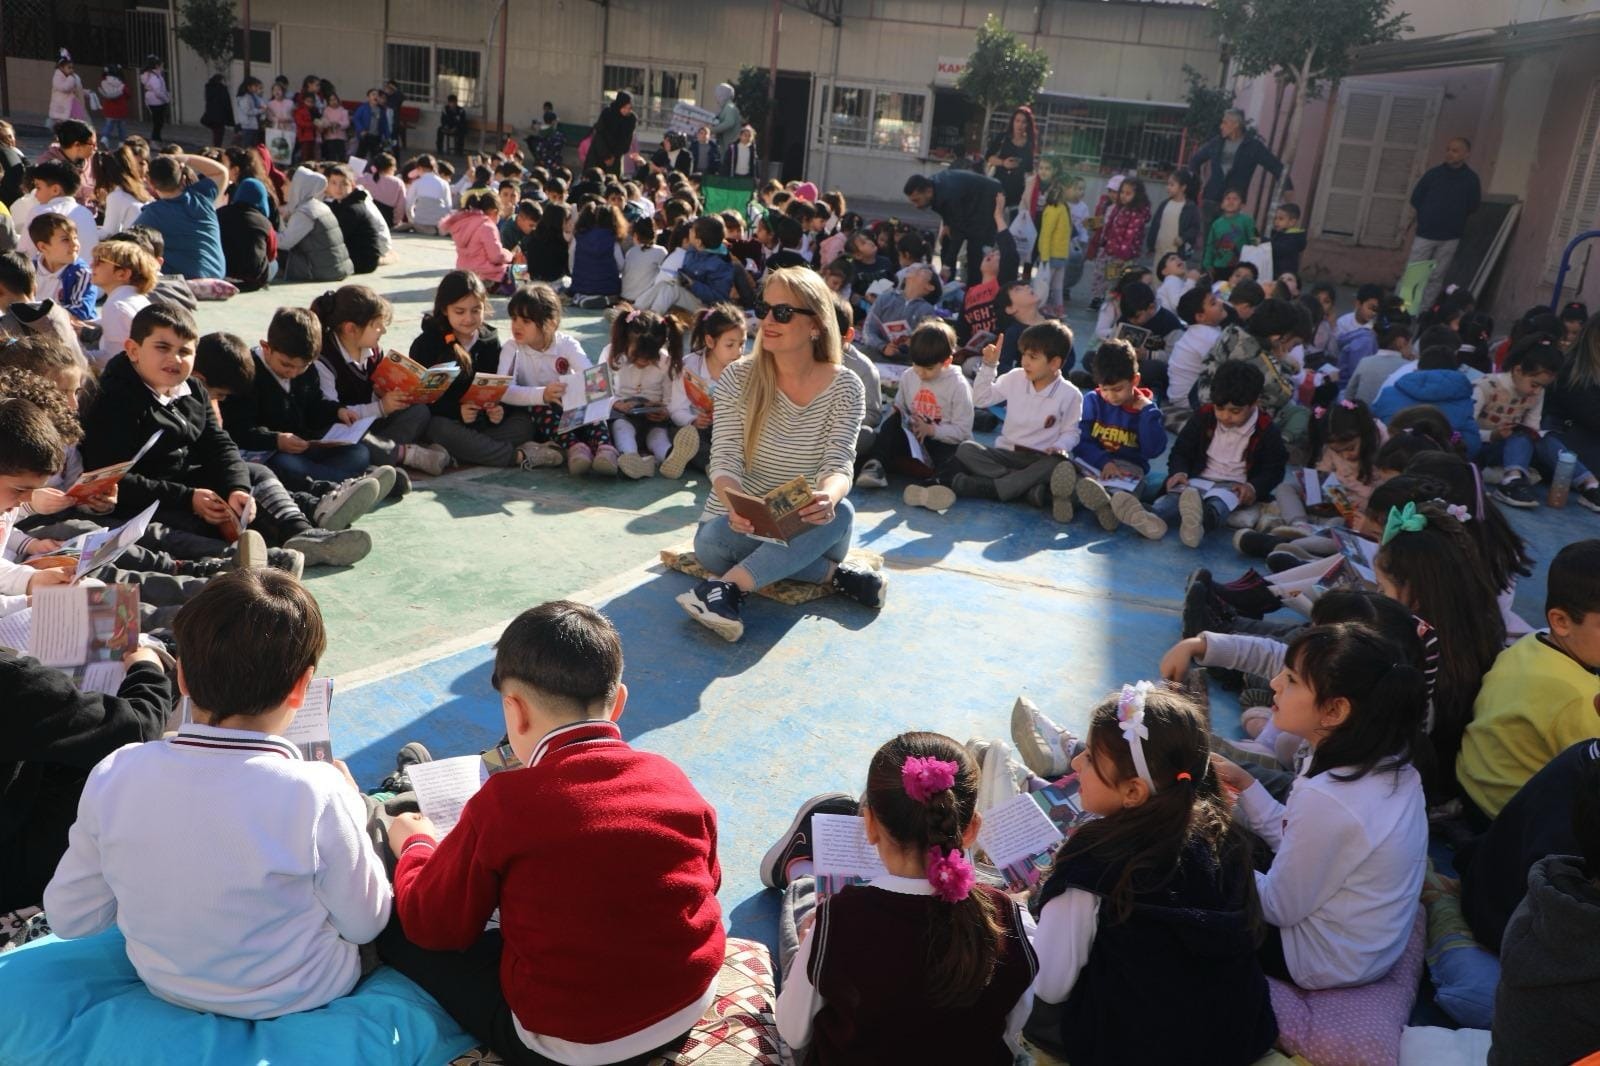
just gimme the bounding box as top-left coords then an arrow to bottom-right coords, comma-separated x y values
678,267 -> 888,640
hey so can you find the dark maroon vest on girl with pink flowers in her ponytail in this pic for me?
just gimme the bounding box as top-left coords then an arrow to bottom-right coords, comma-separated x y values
805,885 -> 1038,1066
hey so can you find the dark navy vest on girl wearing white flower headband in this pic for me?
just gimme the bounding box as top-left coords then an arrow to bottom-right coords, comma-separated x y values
1027,840 -> 1278,1066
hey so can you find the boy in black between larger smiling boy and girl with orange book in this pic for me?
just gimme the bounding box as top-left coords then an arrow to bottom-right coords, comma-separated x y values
222,307 -> 371,491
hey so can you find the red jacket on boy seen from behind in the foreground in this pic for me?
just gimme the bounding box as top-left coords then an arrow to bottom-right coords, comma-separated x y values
395,720 -> 723,1044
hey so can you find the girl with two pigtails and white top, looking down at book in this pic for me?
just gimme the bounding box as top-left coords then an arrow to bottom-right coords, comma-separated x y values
600,302 -> 697,479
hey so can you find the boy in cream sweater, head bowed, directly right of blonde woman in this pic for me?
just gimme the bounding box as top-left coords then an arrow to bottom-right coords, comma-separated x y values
872,319 -> 973,512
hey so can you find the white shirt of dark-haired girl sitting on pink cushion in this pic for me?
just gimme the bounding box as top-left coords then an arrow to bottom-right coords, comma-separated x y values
1238,763 -> 1427,989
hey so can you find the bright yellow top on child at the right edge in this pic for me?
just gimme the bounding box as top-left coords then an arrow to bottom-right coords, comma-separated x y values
1456,632 -> 1600,818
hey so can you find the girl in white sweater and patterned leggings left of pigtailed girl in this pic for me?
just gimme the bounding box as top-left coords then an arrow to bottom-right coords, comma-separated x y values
499,282 -> 618,477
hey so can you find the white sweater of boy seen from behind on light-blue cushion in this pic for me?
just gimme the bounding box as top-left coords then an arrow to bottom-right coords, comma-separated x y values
45,725 -> 390,1018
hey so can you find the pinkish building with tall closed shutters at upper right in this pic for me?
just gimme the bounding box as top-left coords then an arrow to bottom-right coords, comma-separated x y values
1240,0 -> 1600,330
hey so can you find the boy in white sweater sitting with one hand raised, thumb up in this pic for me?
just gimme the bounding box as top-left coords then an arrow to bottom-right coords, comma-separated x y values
950,322 -> 1083,517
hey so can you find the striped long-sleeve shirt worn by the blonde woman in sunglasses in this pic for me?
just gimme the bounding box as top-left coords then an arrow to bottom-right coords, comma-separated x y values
701,355 -> 866,522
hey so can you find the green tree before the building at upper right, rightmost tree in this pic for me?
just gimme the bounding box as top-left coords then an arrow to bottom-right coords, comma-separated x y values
1211,0 -> 1410,168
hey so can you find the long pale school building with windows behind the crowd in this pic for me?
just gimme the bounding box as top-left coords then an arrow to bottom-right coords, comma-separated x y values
5,0 -> 1221,198
